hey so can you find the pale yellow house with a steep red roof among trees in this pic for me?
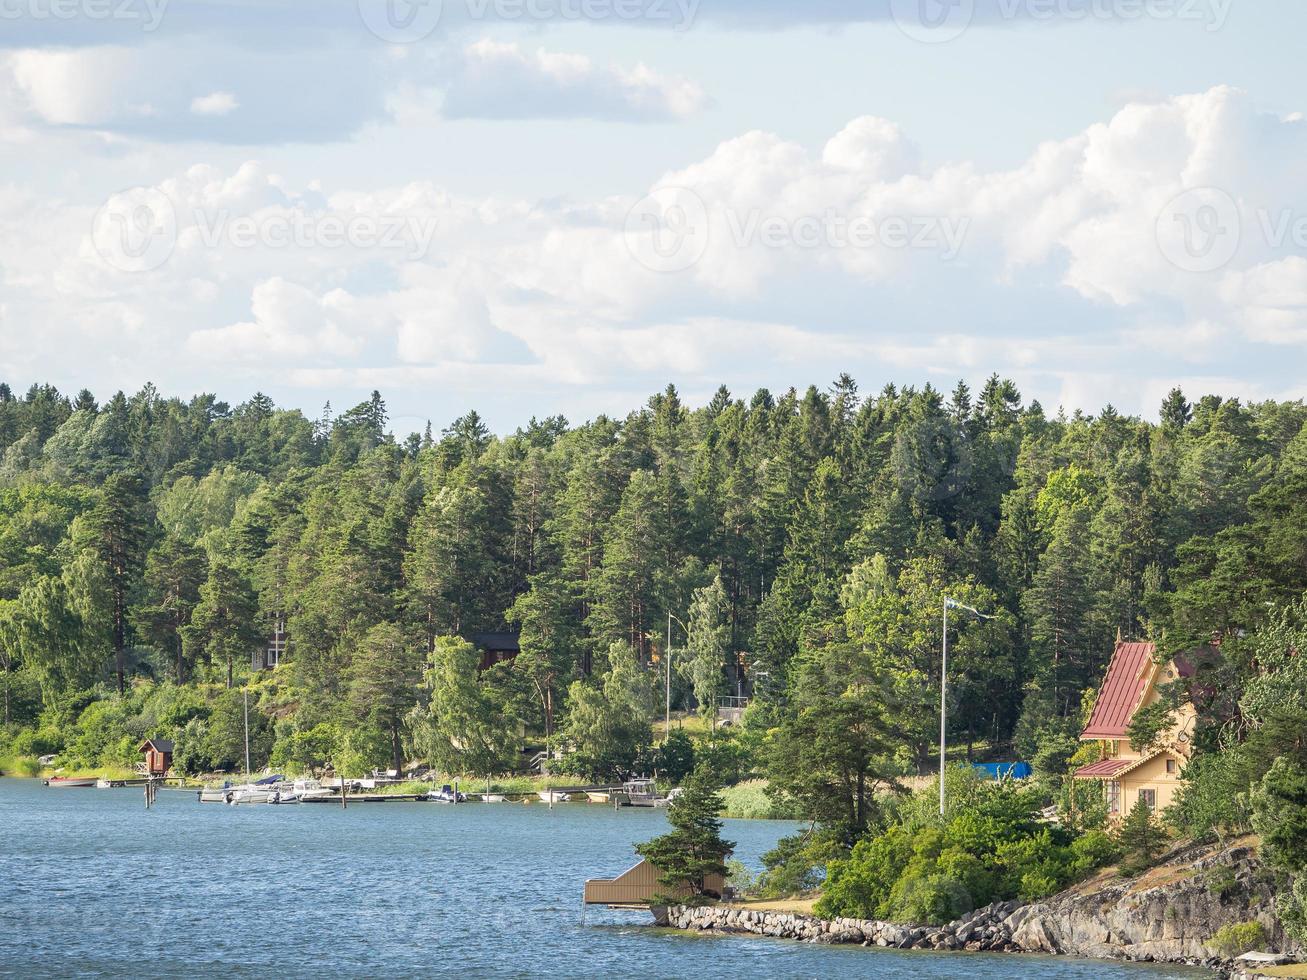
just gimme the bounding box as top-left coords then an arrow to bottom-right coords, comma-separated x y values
1074,640 -> 1197,821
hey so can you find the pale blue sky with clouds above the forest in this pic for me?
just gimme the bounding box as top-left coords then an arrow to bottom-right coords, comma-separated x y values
0,0 -> 1307,434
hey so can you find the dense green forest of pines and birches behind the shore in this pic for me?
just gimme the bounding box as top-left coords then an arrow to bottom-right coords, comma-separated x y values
0,376 -> 1307,925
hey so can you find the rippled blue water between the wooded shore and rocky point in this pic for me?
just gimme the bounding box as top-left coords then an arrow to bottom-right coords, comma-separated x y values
0,779 -> 1201,980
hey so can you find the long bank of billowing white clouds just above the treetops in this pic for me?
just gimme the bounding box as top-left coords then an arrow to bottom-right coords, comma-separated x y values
0,84 -> 1307,423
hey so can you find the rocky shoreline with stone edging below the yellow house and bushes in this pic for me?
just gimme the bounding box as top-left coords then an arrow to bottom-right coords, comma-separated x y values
656,847 -> 1302,975
